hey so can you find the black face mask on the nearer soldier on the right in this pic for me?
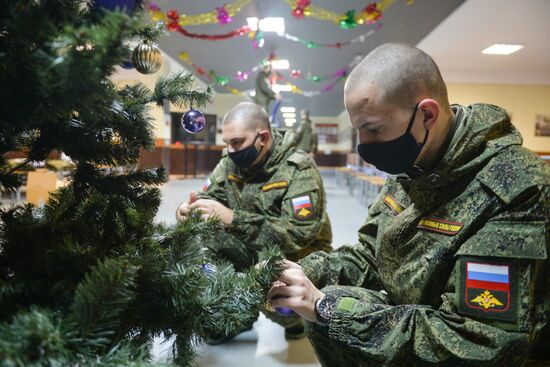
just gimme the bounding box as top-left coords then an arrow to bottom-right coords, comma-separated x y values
357,104 -> 429,174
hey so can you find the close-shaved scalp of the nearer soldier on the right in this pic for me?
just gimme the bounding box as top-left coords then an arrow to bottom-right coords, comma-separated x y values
344,43 -> 449,108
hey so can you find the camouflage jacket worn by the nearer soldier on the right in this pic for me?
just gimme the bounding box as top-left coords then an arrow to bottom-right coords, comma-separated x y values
301,104 -> 550,366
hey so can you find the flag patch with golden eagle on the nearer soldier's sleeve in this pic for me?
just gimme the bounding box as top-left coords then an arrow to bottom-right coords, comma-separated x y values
459,261 -> 517,321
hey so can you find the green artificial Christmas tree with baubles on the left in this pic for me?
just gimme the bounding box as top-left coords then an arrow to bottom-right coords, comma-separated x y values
0,0 -> 281,366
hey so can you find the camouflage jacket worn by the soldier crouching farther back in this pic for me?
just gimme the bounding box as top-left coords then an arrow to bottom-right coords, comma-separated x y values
199,130 -> 332,260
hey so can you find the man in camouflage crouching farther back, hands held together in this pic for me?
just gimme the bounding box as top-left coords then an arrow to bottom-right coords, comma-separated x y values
176,102 -> 332,337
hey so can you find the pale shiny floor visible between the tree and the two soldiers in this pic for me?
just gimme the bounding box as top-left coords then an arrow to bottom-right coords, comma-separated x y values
154,171 -> 367,367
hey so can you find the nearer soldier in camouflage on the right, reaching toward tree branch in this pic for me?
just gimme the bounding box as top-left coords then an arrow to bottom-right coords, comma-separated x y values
268,44 -> 550,366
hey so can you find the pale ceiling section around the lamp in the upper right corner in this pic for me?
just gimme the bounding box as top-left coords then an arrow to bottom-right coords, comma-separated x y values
418,0 -> 550,85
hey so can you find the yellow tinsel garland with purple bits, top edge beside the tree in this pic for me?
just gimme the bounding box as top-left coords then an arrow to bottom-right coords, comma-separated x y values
149,0 -> 251,27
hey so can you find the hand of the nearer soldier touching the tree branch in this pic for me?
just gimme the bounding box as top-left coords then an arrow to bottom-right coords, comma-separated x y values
267,260 -> 325,321
